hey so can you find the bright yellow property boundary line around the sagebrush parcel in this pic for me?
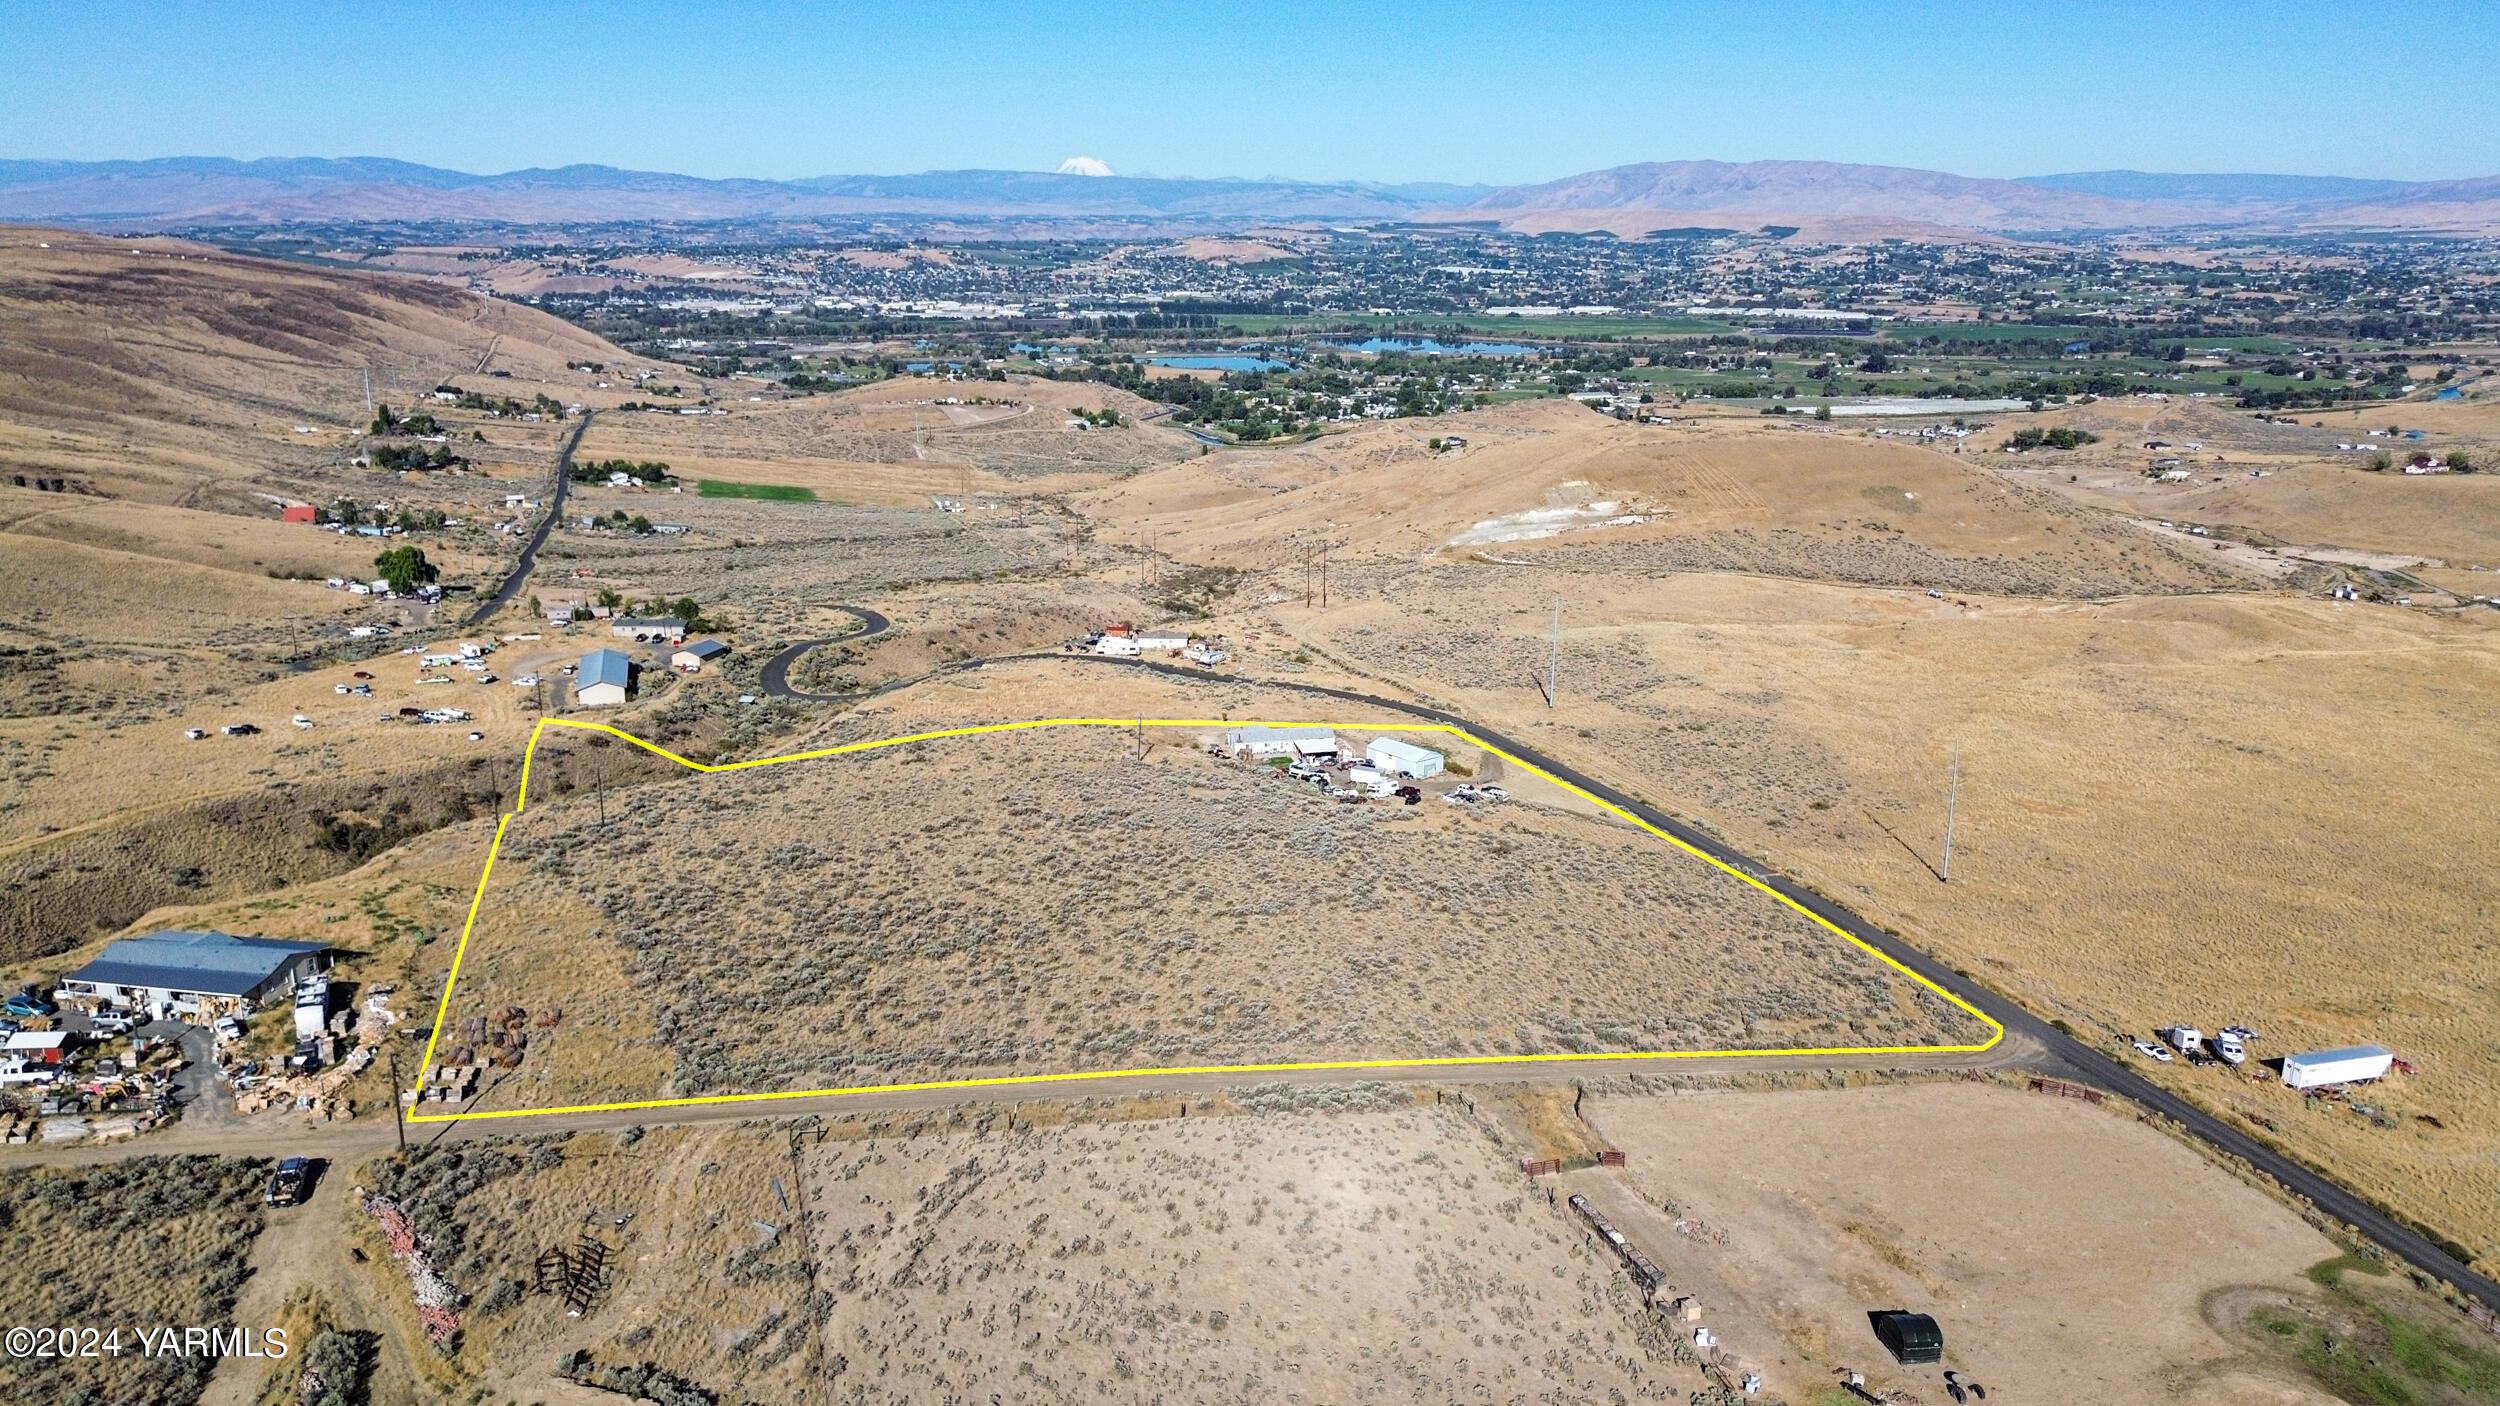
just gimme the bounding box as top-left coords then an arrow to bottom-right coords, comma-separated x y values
408,718 -> 2005,1123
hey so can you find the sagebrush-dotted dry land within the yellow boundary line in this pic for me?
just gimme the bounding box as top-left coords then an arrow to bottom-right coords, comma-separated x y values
453,728 -> 1985,1108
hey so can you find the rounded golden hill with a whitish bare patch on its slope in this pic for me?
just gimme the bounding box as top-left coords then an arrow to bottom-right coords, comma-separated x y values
1080,403 -> 2240,595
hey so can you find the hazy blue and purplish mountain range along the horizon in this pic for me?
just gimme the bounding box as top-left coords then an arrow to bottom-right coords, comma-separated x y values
0,158 -> 2500,240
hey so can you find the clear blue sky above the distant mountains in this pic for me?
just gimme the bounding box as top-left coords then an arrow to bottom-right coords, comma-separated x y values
0,0 -> 2500,183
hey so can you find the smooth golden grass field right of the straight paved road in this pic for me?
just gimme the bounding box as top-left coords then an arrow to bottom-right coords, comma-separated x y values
1300,557 -> 2500,1258
